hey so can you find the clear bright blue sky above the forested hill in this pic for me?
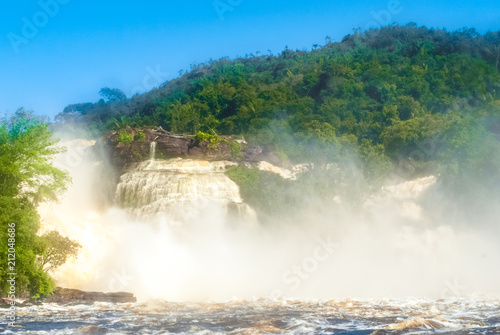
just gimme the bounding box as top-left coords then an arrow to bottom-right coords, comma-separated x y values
0,0 -> 500,116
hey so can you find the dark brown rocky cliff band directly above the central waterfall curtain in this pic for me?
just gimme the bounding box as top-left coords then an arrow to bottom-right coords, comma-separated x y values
102,127 -> 282,171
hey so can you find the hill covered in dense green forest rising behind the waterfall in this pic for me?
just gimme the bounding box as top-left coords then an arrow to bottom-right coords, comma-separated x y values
57,24 -> 500,185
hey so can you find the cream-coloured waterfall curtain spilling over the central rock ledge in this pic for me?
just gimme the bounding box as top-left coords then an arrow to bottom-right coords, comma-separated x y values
115,158 -> 249,221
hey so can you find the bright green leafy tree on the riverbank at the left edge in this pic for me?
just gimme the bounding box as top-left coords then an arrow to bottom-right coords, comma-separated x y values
0,109 -> 77,298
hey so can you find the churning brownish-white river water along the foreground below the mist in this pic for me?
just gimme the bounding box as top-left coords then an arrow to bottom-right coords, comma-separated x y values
0,299 -> 500,335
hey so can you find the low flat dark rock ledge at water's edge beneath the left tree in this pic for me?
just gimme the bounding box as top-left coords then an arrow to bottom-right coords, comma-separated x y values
45,287 -> 137,304
